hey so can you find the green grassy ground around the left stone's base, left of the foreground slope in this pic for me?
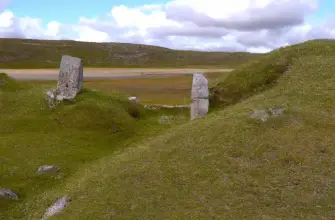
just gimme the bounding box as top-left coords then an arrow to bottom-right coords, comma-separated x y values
0,74 -> 188,219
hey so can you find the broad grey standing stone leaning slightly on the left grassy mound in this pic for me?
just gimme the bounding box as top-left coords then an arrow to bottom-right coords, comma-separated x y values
57,55 -> 83,99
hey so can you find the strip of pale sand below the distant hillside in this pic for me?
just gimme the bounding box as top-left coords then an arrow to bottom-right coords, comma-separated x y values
0,68 -> 232,75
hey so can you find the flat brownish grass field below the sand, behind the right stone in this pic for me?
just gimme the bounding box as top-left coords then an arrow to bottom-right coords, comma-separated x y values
85,72 -> 228,105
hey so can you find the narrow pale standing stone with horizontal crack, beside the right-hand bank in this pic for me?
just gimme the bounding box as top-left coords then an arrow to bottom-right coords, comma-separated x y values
191,73 -> 209,120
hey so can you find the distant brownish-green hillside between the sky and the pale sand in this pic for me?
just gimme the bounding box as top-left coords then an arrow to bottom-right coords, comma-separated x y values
0,39 -> 261,68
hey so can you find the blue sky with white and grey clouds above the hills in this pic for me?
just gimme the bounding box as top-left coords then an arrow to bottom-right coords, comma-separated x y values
0,0 -> 335,53
